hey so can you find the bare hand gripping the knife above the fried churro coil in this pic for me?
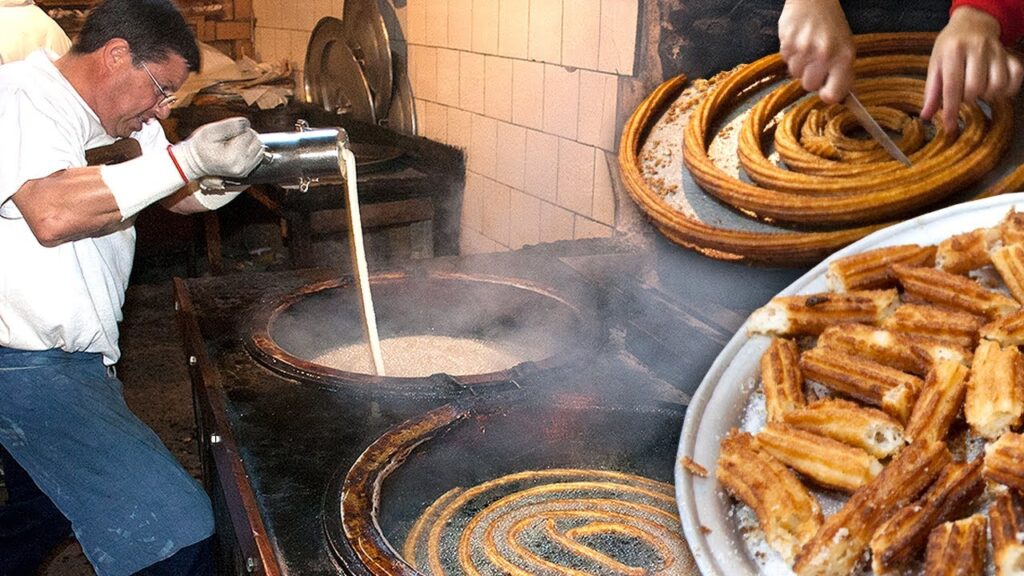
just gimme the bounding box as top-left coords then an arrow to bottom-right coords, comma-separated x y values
778,0 -> 856,104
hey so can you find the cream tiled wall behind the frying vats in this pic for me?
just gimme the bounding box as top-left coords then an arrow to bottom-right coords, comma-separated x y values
253,0 -> 639,253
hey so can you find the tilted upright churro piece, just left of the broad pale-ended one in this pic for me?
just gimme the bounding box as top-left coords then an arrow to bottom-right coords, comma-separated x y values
903,361 -> 969,442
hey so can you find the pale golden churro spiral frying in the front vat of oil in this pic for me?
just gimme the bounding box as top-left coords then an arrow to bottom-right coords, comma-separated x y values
403,469 -> 693,576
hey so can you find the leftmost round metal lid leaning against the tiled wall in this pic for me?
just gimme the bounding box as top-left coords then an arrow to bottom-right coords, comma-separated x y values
304,16 -> 377,124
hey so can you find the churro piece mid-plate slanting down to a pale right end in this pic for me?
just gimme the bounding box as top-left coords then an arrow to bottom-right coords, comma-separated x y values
800,348 -> 923,422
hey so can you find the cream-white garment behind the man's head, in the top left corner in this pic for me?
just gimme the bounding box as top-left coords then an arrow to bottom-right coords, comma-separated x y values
0,0 -> 71,64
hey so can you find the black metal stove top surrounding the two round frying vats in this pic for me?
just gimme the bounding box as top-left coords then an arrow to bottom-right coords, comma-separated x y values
175,241 -> 797,575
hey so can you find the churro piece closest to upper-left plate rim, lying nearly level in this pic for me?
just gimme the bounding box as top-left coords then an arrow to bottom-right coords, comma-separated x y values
825,244 -> 935,292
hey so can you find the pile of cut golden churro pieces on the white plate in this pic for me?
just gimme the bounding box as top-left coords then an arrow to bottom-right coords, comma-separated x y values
716,210 -> 1024,576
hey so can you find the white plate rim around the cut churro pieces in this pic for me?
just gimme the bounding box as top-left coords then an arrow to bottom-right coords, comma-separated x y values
676,193 -> 1024,576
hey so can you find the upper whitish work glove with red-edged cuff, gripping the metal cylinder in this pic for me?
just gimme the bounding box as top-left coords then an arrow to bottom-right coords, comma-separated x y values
171,117 -> 263,180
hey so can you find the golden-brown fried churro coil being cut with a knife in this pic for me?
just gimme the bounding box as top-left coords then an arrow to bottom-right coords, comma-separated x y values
683,34 -> 1013,228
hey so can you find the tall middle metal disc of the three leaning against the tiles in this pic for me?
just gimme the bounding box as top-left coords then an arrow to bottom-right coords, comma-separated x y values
342,0 -> 393,118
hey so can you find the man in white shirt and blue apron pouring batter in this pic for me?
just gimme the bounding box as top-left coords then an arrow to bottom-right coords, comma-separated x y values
0,0 -> 262,576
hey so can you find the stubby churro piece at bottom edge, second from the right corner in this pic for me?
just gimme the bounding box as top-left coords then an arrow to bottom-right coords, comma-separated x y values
925,515 -> 986,576
